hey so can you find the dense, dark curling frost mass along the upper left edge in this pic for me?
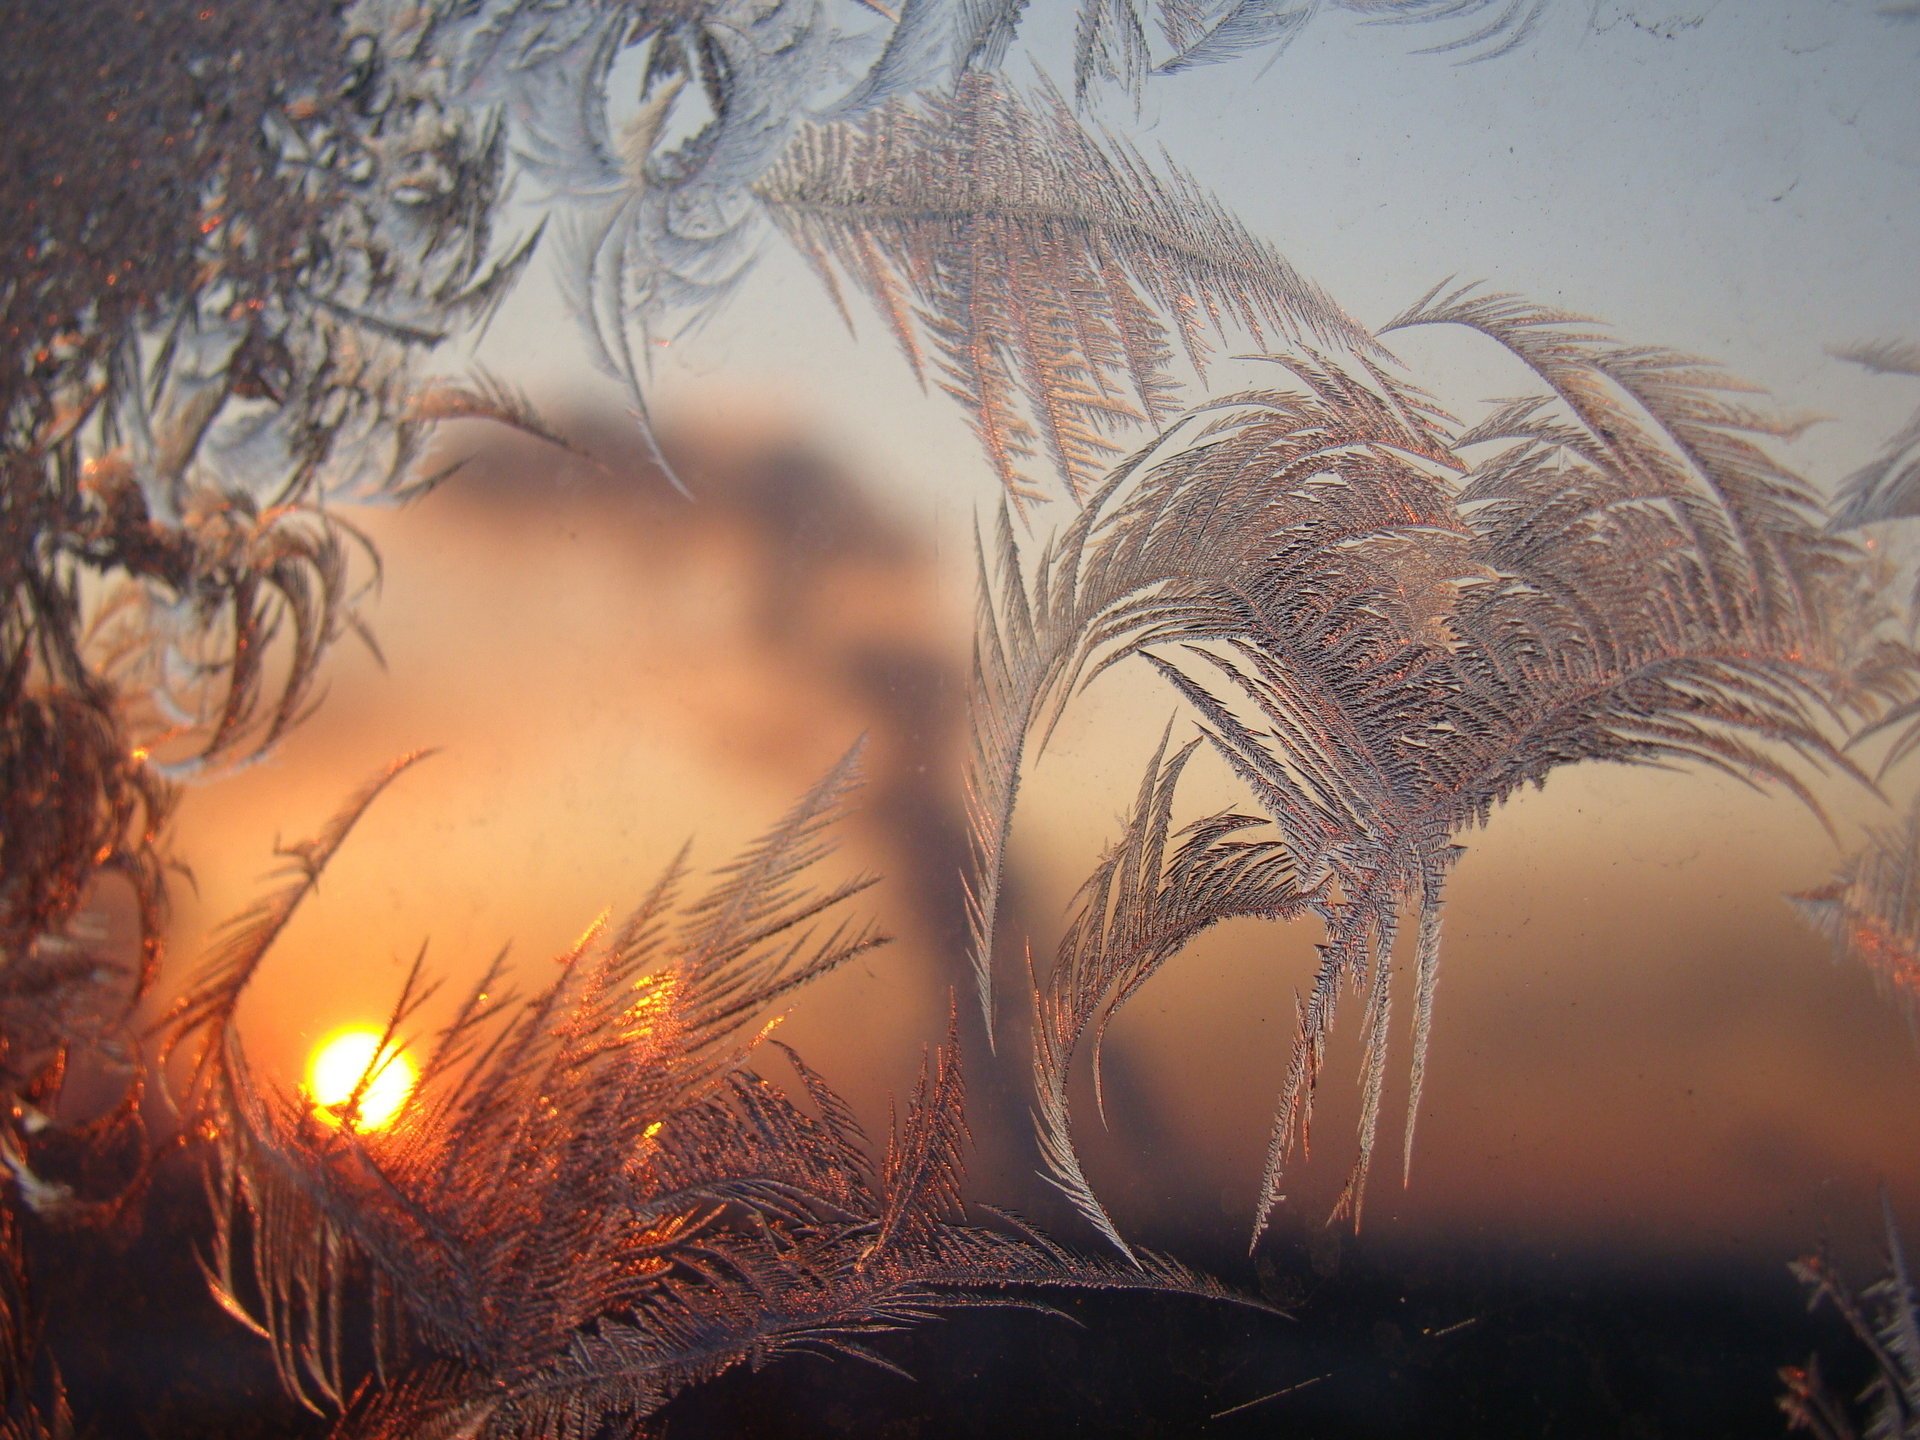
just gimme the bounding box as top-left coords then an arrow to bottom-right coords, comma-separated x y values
0,0 -> 568,1113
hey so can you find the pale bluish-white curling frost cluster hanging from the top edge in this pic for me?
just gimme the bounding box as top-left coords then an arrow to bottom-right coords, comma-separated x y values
447,0 -> 898,484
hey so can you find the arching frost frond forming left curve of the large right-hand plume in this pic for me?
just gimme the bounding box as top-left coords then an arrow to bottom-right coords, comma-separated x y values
968,347 -> 1471,1036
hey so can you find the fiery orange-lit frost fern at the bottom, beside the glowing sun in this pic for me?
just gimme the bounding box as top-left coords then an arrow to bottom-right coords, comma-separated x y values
173,756 -> 1259,1440
